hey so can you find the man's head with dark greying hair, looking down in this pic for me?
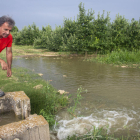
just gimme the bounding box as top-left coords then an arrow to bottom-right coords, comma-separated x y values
0,16 -> 15,38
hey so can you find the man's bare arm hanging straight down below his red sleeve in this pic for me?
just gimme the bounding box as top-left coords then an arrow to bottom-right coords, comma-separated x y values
6,47 -> 12,77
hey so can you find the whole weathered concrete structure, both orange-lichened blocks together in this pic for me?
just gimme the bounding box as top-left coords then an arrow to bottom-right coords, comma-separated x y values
0,91 -> 50,140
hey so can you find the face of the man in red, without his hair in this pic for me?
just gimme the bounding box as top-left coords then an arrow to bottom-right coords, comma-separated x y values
0,22 -> 12,38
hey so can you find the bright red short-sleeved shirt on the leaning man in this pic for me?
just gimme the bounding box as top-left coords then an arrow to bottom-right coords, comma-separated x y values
0,34 -> 13,52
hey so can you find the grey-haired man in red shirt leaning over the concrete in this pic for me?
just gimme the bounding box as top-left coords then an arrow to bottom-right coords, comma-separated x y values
0,16 -> 15,97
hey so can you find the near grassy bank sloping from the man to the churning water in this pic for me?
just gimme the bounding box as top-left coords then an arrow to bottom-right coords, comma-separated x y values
0,68 -> 68,126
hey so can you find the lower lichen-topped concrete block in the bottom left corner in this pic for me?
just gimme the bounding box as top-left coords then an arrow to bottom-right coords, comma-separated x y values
0,115 -> 50,140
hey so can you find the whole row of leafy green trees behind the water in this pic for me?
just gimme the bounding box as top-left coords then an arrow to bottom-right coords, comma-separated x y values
12,3 -> 140,54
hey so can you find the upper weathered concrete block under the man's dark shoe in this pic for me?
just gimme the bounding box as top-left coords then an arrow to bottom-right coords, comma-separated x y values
0,91 -> 31,119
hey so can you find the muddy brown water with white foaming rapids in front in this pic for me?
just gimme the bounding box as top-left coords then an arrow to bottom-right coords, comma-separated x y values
13,57 -> 140,139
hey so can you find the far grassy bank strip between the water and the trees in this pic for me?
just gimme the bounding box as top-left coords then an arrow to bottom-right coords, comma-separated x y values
11,44 -> 140,68
